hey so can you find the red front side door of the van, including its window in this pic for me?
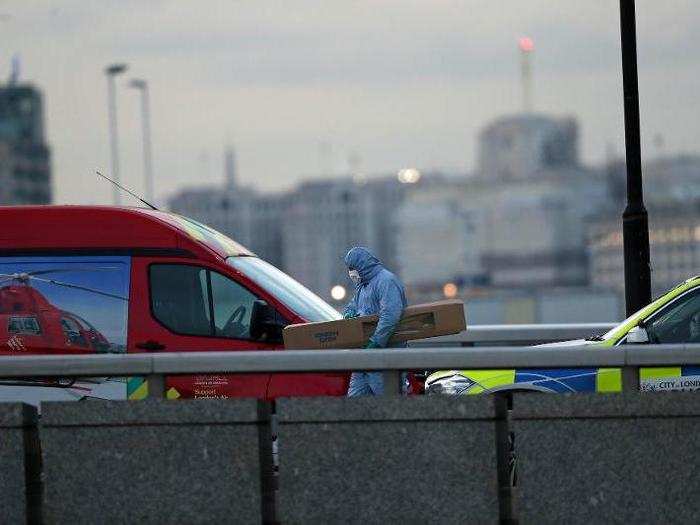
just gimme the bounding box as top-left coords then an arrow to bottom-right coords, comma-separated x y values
128,258 -> 274,399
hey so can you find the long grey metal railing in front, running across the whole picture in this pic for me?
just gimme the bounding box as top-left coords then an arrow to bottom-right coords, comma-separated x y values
0,344 -> 700,397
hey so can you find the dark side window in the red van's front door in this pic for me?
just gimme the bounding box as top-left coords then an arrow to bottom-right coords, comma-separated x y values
150,264 -> 257,339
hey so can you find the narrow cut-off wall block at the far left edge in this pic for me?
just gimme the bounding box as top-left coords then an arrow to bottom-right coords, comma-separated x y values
0,403 -> 38,523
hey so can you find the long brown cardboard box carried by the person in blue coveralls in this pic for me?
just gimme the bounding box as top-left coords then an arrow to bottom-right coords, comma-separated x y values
283,300 -> 466,349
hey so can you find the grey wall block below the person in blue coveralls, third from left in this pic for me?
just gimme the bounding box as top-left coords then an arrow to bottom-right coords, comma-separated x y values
277,396 -> 498,524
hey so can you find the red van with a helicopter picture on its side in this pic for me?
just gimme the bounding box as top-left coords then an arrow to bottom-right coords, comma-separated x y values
0,206 -> 348,402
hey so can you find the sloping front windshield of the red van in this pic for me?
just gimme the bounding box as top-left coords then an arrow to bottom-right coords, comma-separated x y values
226,256 -> 341,323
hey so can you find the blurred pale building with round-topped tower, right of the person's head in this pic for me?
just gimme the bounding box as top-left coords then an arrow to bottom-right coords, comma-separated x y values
397,114 -> 610,297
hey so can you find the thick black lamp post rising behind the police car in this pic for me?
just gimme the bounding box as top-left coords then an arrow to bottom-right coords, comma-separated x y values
620,0 -> 651,316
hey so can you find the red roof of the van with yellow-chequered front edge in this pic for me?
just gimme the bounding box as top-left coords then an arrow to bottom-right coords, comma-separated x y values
0,206 -> 253,258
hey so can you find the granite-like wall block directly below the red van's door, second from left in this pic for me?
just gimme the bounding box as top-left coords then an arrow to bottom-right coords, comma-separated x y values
40,400 -> 261,524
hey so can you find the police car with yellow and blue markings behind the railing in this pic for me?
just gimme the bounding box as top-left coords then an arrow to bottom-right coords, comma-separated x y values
425,276 -> 700,395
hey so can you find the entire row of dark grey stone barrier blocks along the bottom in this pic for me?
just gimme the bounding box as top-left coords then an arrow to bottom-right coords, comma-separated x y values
5,386 -> 700,524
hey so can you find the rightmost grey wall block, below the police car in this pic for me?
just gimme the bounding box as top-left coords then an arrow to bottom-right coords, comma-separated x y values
512,393 -> 700,524
